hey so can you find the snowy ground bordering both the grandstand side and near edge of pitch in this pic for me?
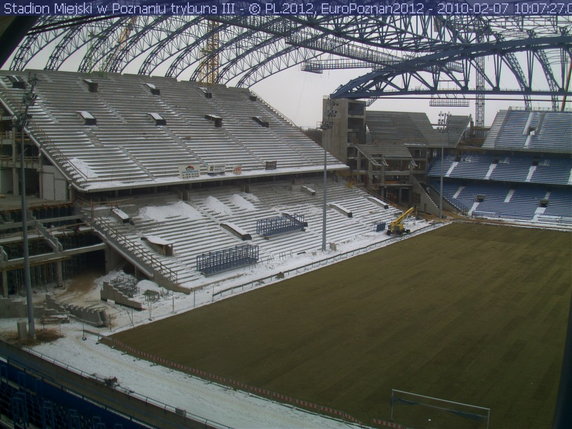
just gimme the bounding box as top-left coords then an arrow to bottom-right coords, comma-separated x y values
0,219 -> 442,429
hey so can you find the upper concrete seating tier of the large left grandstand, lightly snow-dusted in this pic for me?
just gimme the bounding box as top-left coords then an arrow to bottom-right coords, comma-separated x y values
0,71 -> 341,186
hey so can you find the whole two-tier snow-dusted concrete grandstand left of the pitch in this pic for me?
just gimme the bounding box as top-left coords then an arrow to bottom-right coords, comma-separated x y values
0,71 -> 418,294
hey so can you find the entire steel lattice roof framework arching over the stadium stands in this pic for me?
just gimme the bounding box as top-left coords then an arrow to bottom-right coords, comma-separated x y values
8,15 -> 572,101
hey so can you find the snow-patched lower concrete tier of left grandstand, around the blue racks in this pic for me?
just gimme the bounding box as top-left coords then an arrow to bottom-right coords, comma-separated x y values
96,182 -> 400,287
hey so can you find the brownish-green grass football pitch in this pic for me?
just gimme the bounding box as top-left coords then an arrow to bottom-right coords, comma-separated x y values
114,224 -> 572,429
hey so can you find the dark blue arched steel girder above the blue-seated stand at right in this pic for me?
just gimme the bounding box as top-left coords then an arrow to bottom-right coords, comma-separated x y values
332,35 -> 572,98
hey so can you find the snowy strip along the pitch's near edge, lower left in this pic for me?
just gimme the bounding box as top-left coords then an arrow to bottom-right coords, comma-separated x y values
21,330 -> 366,429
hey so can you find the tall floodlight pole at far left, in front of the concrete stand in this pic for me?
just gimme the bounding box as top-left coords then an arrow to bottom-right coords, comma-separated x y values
16,76 -> 37,340
